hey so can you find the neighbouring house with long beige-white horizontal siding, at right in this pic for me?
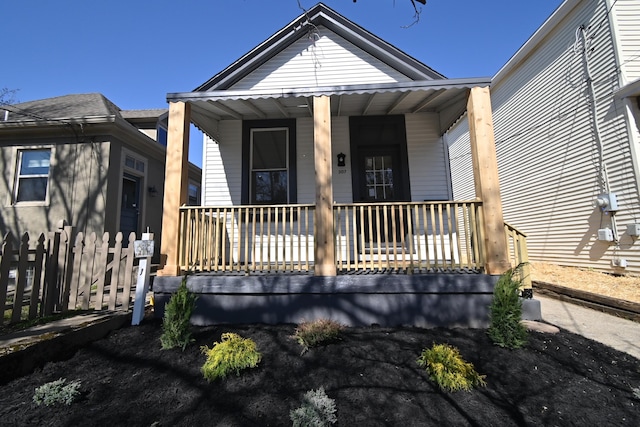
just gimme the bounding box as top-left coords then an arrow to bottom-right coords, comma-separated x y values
448,0 -> 640,275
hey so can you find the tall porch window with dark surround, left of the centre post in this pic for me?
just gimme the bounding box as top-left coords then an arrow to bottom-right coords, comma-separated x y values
242,120 -> 296,205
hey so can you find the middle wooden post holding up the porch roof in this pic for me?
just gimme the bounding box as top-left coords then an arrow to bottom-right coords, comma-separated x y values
313,96 -> 336,276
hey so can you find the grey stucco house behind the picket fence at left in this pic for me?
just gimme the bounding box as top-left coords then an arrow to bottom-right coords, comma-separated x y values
0,93 -> 201,260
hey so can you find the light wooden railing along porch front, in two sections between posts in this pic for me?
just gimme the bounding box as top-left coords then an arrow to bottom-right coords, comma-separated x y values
179,201 -> 484,274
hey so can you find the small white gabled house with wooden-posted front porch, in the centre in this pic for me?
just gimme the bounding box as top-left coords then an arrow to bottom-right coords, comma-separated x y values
154,3 -> 521,325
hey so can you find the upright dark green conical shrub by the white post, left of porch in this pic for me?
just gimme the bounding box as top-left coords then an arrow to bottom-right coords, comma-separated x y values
160,276 -> 196,351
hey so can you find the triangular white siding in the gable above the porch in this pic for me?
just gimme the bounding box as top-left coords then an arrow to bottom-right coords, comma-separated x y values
231,27 -> 410,90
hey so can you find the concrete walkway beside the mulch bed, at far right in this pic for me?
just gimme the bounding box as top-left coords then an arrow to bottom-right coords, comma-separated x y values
535,294 -> 640,360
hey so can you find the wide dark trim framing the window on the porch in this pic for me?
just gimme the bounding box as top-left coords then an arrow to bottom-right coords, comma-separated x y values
241,119 -> 298,205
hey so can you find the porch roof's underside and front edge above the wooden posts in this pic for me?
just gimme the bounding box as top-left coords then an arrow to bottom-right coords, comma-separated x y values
167,78 -> 491,135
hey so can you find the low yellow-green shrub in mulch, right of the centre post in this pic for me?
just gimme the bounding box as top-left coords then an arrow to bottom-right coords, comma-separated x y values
417,344 -> 485,392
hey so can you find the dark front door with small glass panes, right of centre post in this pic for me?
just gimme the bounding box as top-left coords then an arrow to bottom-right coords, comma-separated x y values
350,116 -> 411,246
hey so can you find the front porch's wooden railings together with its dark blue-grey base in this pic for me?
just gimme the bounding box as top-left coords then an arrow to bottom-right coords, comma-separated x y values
154,197 -> 530,328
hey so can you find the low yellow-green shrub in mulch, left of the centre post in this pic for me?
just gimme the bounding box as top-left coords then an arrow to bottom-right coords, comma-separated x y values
201,333 -> 262,381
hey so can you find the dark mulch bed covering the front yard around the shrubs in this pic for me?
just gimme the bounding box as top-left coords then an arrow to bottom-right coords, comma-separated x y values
0,319 -> 640,427
